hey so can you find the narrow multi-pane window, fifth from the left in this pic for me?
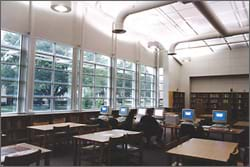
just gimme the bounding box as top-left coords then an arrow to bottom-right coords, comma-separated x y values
140,65 -> 155,107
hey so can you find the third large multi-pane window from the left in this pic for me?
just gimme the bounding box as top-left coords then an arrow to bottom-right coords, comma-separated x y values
82,52 -> 110,109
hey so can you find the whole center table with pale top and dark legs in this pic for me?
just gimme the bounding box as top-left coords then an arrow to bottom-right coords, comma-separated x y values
73,129 -> 141,165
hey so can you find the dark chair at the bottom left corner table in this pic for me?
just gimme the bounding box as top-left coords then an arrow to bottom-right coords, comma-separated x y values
3,149 -> 42,166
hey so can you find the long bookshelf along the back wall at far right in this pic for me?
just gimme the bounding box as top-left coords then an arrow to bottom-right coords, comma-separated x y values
190,92 -> 249,121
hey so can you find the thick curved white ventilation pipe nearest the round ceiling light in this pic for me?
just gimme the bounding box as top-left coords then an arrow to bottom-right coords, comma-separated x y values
112,0 -> 177,34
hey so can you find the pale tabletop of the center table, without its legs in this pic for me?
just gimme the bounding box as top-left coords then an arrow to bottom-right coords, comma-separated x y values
74,129 -> 141,143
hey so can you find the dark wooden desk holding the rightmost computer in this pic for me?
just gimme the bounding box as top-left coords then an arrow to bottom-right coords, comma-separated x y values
203,126 -> 244,141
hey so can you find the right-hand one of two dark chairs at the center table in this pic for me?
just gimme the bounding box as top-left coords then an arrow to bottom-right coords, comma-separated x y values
126,133 -> 143,164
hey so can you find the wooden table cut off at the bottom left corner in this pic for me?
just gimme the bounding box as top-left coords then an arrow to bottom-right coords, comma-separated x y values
1,143 -> 51,166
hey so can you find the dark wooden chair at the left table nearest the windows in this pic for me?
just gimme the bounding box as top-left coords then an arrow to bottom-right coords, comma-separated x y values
52,125 -> 72,149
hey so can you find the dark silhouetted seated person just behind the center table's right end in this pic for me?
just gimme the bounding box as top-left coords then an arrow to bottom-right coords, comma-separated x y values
139,110 -> 163,144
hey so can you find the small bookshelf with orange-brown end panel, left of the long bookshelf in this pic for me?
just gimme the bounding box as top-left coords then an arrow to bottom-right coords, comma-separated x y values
169,91 -> 185,113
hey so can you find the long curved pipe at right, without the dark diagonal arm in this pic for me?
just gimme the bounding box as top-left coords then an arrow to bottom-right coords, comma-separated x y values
168,27 -> 249,55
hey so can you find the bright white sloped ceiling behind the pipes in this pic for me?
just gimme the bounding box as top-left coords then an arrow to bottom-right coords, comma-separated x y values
82,1 -> 249,53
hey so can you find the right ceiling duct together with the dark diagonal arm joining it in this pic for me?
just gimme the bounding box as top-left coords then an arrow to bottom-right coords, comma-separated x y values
168,1 -> 249,55
